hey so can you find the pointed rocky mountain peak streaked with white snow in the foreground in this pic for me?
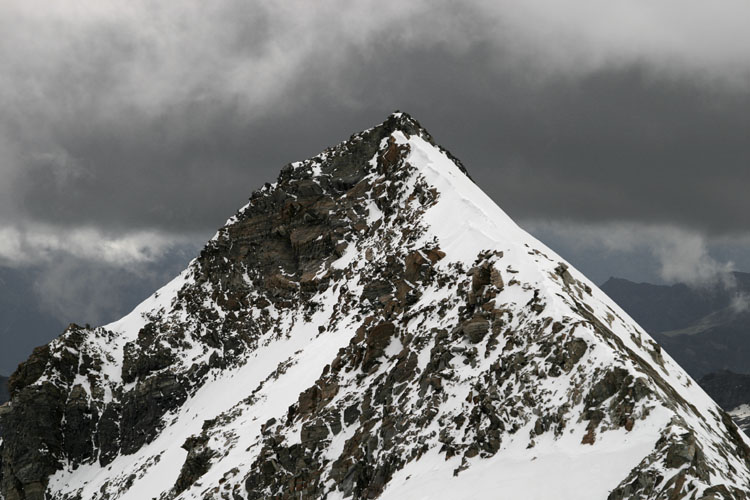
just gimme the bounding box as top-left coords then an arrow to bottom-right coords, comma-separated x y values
0,113 -> 750,500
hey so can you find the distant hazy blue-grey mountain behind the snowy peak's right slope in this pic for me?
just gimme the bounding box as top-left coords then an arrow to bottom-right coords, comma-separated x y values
602,272 -> 750,379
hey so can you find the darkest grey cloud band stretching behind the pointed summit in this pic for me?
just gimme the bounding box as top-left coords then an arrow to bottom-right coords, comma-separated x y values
5,53 -> 750,237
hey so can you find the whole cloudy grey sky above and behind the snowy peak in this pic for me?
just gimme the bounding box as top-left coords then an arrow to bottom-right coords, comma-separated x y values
0,0 -> 750,371
